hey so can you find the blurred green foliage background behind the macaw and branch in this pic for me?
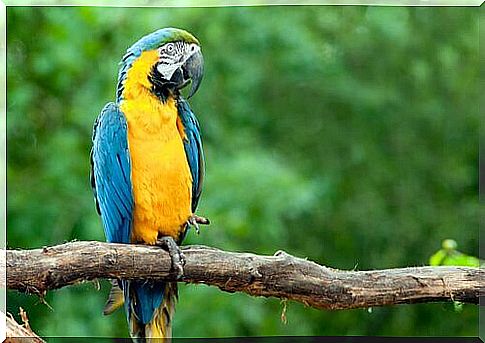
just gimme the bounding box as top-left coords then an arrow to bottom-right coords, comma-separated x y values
7,6 -> 479,337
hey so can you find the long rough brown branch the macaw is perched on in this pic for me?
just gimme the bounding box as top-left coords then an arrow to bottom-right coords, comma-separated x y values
2,242 -> 485,309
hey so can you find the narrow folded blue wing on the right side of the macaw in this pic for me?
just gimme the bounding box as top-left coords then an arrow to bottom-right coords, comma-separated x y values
178,99 -> 205,212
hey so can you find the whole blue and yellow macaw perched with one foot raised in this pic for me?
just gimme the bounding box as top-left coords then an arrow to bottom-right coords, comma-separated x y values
91,28 -> 208,342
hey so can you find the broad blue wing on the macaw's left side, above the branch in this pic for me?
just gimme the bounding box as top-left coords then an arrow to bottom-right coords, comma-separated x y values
91,102 -> 133,243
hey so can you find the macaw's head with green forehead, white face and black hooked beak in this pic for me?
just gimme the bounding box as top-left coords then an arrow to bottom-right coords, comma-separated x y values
118,28 -> 204,99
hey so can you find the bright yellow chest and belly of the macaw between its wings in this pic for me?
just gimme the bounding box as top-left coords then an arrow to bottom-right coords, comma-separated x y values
120,92 -> 192,244
